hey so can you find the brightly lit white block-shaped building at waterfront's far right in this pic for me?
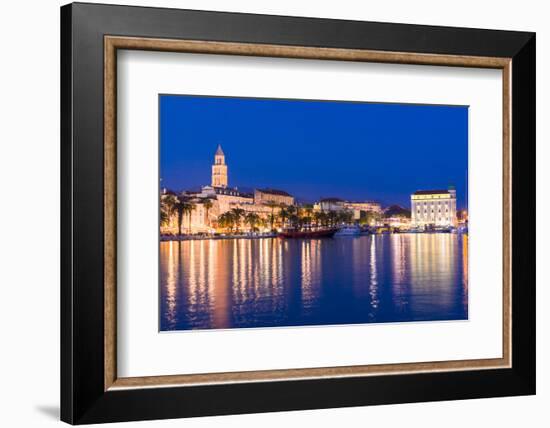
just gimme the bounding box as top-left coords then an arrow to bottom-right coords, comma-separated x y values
411,187 -> 457,227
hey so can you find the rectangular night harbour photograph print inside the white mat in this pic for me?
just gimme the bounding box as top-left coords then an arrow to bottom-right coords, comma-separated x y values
159,94 -> 468,332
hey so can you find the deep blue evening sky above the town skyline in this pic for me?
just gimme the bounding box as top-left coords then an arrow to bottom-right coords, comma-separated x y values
160,95 -> 468,208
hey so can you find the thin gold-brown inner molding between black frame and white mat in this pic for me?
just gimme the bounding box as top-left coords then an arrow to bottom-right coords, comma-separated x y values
104,36 -> 512,391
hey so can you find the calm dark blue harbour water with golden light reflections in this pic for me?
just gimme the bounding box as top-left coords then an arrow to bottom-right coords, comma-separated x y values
160,234 -> 468,331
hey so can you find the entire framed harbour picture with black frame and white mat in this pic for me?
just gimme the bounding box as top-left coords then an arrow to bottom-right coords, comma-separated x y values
61,3 -> 535,424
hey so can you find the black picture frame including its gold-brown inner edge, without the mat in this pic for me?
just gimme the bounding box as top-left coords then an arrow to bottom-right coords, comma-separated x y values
61,3 -> 535,424
